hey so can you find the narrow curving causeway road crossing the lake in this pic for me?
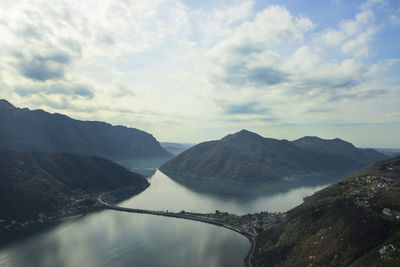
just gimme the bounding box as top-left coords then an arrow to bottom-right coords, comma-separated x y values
97,190 -> 256,267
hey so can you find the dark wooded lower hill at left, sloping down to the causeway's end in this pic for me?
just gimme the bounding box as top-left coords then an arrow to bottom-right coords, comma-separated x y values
0,151 -> 148,220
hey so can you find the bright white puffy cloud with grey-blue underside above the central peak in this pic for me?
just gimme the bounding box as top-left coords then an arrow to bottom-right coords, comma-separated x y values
209,6 -> 313,87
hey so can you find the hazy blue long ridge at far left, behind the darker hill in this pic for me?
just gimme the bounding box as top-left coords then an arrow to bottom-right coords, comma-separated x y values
0,100 -> 172,160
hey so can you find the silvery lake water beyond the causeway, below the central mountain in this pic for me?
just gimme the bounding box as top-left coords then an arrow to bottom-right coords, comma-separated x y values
120,171 -> 332,214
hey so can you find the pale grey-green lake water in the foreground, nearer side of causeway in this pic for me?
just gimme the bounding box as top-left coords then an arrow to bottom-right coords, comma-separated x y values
0,211 -> 249,267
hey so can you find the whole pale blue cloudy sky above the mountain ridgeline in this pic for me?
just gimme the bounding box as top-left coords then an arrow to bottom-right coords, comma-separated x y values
0,0 -> 400,148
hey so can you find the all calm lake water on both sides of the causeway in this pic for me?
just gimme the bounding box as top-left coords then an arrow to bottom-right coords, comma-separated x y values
0,171 -> 332,267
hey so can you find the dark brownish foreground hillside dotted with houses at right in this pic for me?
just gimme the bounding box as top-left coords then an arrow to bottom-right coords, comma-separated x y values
253,156 -> 400,266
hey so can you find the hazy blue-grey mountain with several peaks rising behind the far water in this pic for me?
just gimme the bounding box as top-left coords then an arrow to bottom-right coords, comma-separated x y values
160,130 -> 387,183
